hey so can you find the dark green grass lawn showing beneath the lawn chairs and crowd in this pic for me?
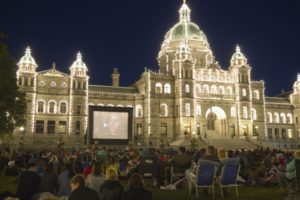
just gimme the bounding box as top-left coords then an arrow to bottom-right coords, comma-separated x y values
0,176 -> 284,200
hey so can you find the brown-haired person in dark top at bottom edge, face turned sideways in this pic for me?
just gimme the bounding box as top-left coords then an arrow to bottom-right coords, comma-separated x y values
69,174 -> 99,200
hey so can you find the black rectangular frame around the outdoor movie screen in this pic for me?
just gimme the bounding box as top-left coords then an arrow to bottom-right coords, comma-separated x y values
87,105 -> 133,145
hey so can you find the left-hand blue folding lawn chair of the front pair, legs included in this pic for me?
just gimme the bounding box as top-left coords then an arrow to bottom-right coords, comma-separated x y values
189,161 -> 219,198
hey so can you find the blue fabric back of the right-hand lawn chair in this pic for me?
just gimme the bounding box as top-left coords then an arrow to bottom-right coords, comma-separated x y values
220,165 -> 240,185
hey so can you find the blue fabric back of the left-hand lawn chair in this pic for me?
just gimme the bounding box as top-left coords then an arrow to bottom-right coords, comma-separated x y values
196,163 -> 217,186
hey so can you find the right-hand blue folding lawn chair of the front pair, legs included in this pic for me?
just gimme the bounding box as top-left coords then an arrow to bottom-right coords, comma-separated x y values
218,165 -> 240,198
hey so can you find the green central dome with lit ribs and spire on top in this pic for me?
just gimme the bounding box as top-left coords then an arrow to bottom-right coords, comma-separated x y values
163,3 -> 208,46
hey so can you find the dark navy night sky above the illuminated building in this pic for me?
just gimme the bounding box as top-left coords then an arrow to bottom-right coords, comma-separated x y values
0,0 -> 300,95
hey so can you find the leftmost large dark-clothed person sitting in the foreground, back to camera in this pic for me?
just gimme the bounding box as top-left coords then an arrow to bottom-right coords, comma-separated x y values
17,163 -> 41,200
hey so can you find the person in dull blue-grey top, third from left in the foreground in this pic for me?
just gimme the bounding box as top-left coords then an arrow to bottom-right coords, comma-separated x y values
58,163 -> 75,196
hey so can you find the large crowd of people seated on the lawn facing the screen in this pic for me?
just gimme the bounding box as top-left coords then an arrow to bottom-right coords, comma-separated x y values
0,145 -> 300,200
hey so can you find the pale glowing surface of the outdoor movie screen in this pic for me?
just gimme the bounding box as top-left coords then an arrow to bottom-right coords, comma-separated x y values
93,111 -> 128,140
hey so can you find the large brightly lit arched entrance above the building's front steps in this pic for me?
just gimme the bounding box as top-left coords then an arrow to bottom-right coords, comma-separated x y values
204,106 -> 227,137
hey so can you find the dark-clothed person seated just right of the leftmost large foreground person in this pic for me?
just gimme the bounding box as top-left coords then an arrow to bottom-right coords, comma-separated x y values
39,162 -> 58,194
